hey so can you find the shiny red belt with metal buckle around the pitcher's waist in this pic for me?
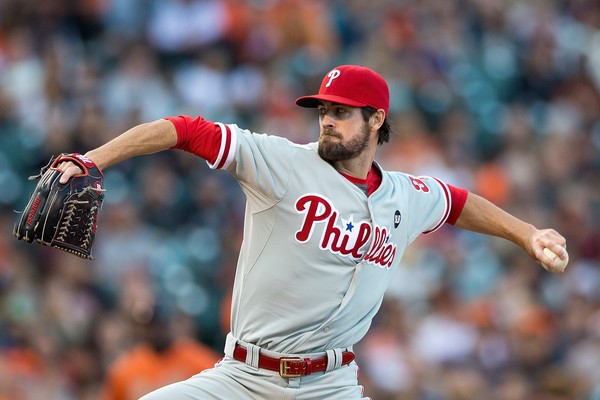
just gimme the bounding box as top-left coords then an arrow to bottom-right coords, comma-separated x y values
233,344 -> 354,378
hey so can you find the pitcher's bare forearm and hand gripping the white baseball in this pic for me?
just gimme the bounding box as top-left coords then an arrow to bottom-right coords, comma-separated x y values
454,193 -> 568,272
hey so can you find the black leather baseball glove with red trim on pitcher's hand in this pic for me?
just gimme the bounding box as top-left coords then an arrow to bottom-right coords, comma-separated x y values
13,154 -> 105,259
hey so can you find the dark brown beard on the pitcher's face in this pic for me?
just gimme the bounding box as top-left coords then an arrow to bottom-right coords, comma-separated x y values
318,123 -> 370,162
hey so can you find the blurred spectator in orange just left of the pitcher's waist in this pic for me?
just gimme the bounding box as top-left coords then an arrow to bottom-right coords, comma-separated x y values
102,271 -> 221,400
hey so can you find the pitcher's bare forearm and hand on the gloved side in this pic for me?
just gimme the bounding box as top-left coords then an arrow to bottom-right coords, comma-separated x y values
59,119 -> 177,183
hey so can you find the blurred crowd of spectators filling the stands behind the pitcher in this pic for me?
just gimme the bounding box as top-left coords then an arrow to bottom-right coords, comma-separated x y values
0,0 -> 600,400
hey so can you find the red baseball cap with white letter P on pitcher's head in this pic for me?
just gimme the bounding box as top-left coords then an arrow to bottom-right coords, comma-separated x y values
296,65 -> 390,115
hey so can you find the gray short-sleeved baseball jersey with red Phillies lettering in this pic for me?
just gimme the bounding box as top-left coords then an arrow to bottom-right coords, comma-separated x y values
178,117 -> 451,353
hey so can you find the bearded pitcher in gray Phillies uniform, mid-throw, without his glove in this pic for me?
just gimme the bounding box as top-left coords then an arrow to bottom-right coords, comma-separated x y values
61,65 -> 567,400
